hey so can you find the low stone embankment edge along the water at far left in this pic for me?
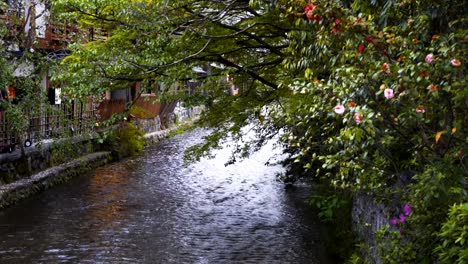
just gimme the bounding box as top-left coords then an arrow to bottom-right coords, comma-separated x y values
0,151 -> 111,210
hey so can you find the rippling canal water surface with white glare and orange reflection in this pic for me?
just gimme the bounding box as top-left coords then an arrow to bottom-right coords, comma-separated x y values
0,130 -> 329,263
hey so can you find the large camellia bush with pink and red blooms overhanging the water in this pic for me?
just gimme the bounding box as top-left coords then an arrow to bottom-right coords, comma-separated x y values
275,1 -> 468,263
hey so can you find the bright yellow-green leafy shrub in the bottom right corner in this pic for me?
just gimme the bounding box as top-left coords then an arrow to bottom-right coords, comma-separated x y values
435,203 -> 468,264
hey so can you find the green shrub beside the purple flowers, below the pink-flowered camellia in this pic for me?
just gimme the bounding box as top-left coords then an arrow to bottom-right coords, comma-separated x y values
379,163 -> 467,263
